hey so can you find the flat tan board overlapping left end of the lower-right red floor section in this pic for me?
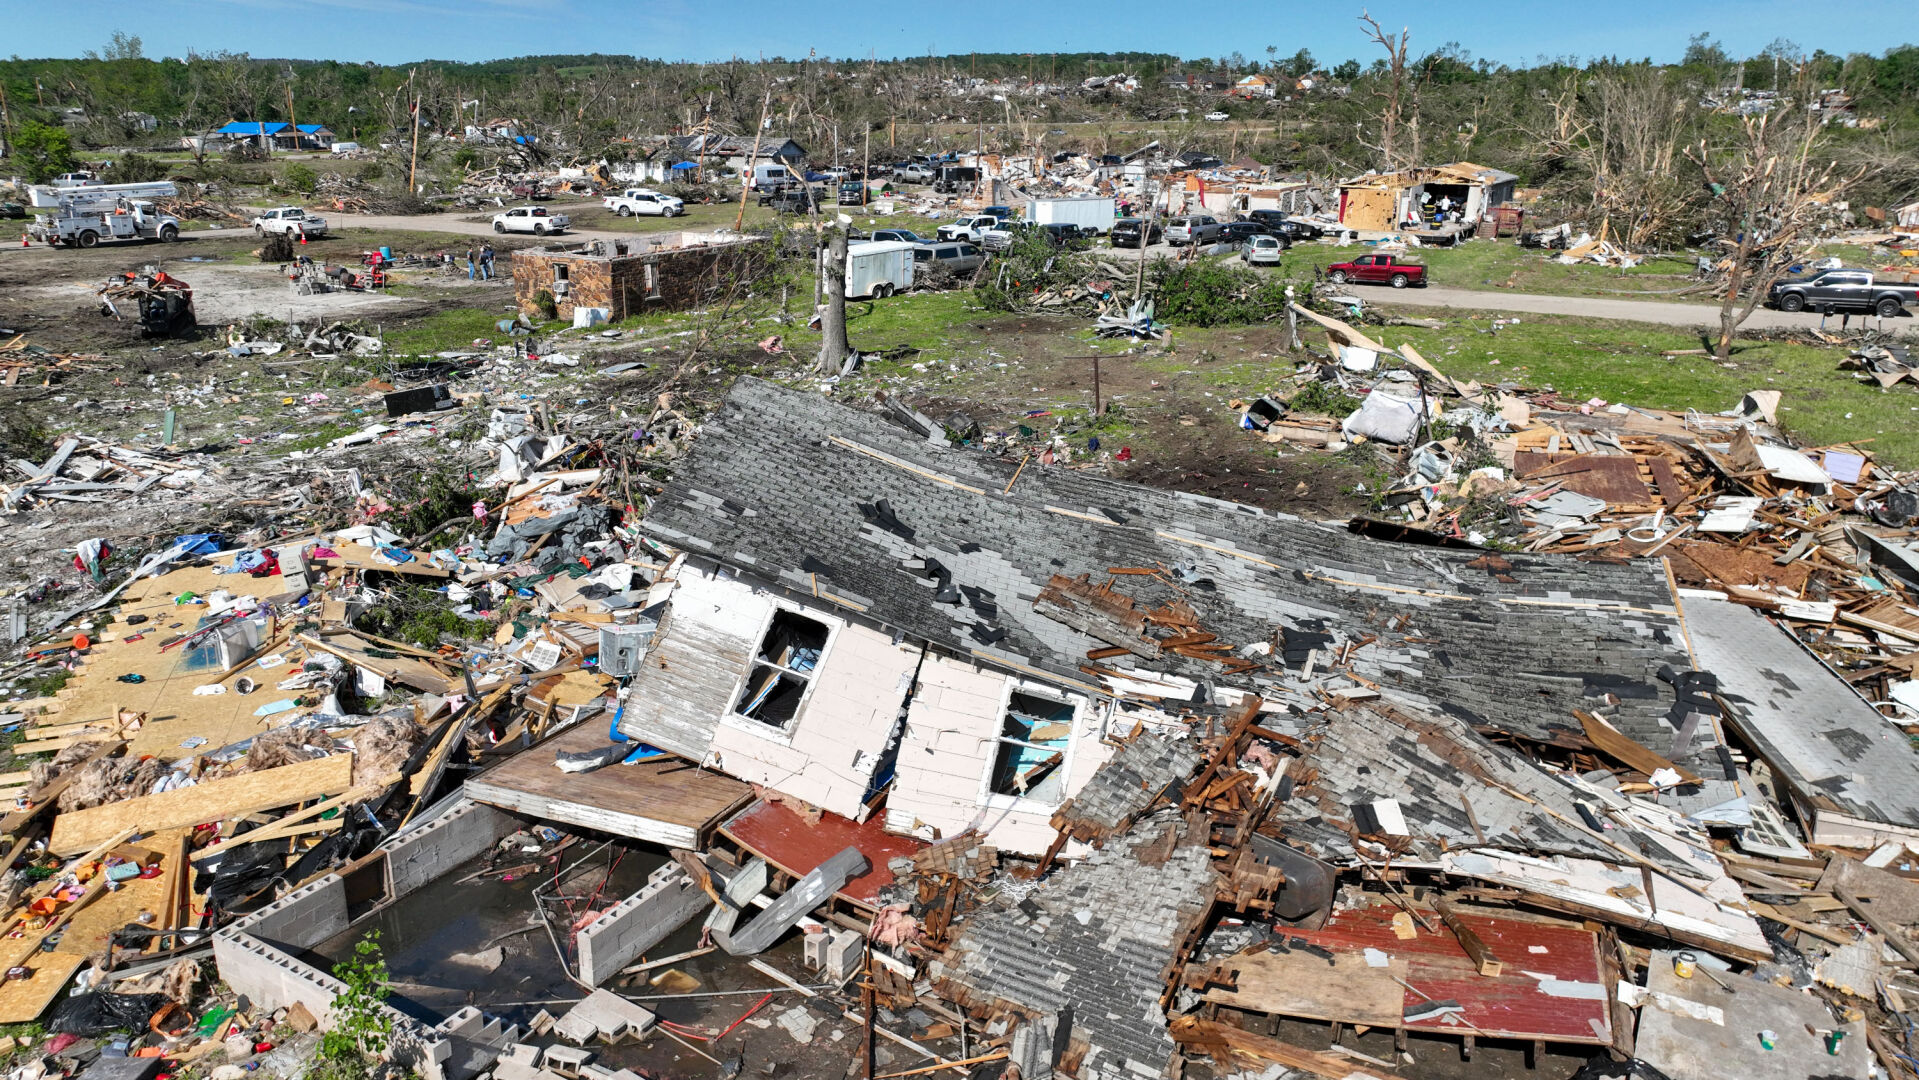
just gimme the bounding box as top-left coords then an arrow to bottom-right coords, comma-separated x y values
1205,951 -> 1407,1028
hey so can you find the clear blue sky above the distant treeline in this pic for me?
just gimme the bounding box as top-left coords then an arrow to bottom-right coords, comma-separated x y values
14,0 -> 1919,63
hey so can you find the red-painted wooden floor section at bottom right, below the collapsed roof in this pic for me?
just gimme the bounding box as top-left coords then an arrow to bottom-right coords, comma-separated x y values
1284,907 -> 1612,1044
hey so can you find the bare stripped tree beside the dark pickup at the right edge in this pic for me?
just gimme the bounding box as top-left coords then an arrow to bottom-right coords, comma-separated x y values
1685,109 -> 1865,363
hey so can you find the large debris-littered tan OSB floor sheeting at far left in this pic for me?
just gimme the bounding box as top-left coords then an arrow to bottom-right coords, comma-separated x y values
54,566 -> 290,760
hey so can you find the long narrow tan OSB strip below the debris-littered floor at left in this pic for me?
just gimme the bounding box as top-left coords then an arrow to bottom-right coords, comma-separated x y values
48,754 -> 353,856
